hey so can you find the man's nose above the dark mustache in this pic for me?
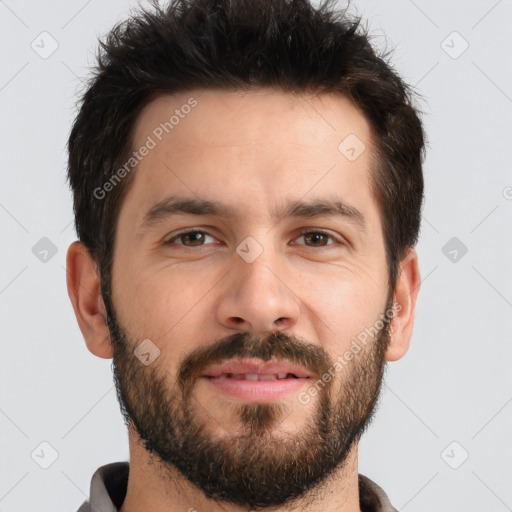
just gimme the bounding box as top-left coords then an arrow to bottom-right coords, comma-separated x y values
217,251 -> 301,335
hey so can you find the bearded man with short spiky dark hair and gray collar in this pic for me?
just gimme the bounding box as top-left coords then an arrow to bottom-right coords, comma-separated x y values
67,0 -> 424,512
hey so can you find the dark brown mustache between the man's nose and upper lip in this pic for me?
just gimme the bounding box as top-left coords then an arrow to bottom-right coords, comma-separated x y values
177,332 -> 333,396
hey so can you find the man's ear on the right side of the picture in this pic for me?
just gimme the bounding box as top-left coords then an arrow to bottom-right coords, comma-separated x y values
386,248 -> 421,361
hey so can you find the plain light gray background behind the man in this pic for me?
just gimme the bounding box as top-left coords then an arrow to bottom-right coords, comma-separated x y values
0,0 -> 512,512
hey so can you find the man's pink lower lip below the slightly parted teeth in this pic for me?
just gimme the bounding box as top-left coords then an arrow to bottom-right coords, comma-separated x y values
202,377 -> 311,402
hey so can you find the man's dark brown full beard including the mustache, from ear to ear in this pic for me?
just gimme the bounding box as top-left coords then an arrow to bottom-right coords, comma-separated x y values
104,290 -> 391,509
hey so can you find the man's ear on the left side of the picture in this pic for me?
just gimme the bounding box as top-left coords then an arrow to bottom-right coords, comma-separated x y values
66,241 -> 113,359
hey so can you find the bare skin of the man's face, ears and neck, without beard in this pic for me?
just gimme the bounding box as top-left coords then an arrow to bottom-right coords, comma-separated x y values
67,88 -> 420,512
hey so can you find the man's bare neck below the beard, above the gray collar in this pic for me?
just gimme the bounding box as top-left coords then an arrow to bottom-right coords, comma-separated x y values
120,428 -> 361,512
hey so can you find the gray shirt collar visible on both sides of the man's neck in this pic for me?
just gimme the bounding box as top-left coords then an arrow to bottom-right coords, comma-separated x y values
78,462 -> 398,512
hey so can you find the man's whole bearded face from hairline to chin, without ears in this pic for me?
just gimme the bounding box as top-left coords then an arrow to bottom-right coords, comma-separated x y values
105,89 -> 391,507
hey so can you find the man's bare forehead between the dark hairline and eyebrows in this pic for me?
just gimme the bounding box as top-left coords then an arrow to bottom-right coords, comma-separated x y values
122,88 -> 375,230
